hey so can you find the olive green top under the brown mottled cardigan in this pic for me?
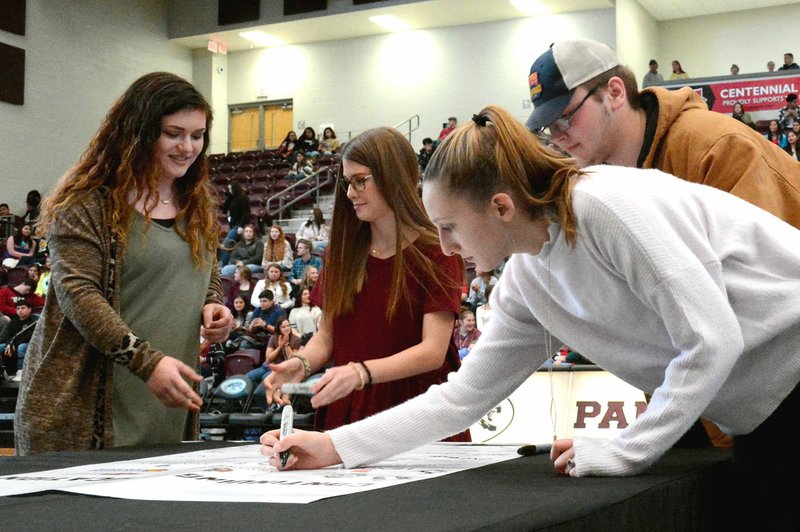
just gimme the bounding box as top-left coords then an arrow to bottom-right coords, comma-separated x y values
114,213 -> 211,445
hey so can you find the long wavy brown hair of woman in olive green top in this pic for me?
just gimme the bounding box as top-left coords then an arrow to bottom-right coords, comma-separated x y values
39,72 -> 219,267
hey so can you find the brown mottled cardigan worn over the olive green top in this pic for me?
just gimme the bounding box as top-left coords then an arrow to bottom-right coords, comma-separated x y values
14,191 -> 222,455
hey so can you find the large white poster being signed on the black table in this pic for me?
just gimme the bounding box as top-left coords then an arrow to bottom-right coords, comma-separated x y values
0,443 -> 518,503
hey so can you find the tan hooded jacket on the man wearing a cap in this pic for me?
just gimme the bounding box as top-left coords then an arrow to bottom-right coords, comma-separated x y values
643,87 -> 800,227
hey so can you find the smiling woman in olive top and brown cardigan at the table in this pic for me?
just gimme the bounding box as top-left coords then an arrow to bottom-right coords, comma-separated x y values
14,72 -> 231,455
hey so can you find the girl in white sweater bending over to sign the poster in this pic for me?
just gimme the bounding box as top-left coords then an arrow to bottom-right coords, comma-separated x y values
261,107 -> 800,516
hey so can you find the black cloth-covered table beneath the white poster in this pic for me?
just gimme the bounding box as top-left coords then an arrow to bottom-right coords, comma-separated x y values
0,442 -> 732,532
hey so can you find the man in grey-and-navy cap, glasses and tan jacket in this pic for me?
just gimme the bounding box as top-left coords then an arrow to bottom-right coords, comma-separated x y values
528,40 -> 800,227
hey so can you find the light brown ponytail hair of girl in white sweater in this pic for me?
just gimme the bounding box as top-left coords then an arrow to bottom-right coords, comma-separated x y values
424,105 -> 581,246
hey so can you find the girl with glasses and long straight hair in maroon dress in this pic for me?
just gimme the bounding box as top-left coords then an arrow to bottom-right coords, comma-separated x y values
265,128 -> 468,440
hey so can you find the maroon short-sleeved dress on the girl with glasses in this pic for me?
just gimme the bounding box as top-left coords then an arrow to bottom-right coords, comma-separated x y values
311,244 -> 470,441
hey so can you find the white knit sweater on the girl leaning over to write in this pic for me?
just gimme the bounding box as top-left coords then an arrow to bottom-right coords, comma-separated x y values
329,166 -> 800,476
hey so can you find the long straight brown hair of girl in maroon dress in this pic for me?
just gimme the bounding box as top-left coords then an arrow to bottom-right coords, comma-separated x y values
324,127 -> 451,321
